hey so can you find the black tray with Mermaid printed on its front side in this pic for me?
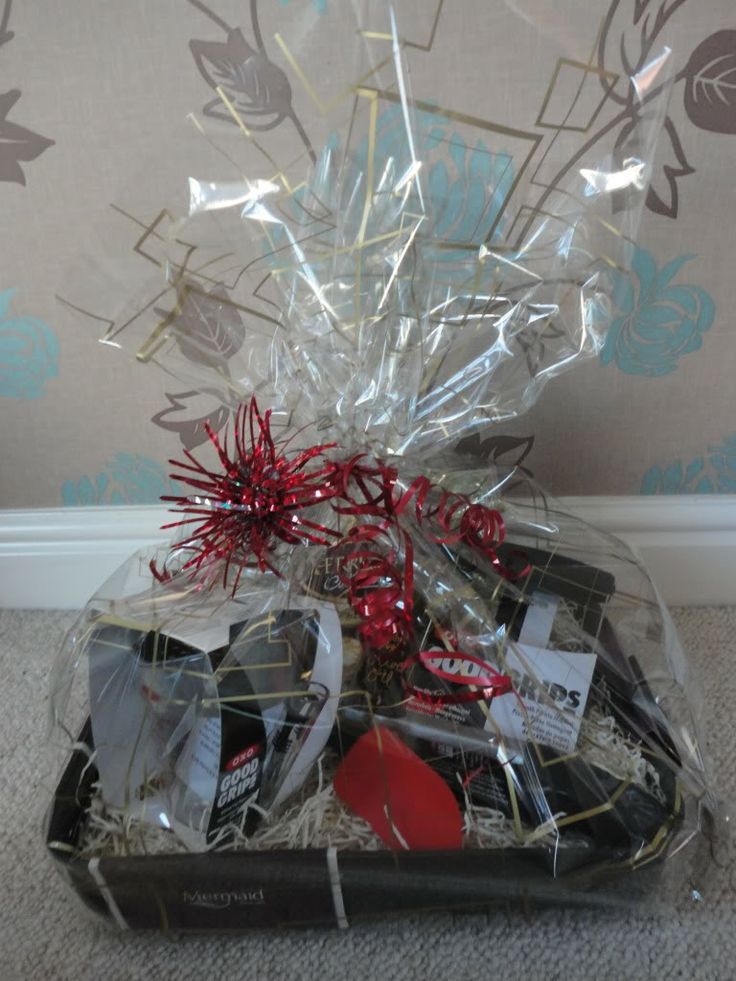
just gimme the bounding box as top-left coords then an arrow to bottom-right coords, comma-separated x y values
46,722 -> 674,934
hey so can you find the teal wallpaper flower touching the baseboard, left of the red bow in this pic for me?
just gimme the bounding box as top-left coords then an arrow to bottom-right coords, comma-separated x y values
61,453 -> 176,507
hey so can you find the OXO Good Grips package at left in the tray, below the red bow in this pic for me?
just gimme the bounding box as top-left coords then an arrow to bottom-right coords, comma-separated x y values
88,598 -> 342,850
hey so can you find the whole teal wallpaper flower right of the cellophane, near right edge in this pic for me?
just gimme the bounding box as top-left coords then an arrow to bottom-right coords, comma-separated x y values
601,248 -> 715,378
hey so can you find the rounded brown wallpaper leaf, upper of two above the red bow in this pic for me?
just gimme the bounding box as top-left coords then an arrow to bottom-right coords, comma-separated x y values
154,283 -> 245,368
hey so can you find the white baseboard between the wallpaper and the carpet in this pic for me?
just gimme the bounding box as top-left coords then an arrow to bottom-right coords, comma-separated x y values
0,495 -> 736,609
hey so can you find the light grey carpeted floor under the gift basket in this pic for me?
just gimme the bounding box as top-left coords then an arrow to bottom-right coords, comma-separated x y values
0,609 -> 736,981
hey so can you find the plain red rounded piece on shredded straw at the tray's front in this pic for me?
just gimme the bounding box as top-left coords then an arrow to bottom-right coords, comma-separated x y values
334,726 -> 463,851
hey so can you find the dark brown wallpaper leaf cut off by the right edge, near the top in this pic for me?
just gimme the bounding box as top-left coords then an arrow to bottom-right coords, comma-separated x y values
684,30 -> 736,134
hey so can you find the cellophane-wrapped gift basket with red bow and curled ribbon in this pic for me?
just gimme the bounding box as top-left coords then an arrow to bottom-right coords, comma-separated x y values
46,2 -> 717,931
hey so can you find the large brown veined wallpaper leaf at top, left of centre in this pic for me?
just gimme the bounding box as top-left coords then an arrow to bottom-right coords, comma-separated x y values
189,0 -> 316,161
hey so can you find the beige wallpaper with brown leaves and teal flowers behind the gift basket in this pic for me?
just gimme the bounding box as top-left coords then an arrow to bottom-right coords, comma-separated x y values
0,0 -> 736,508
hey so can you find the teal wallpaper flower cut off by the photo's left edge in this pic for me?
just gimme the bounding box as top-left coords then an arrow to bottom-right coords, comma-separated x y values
0,290 -> 59,399
